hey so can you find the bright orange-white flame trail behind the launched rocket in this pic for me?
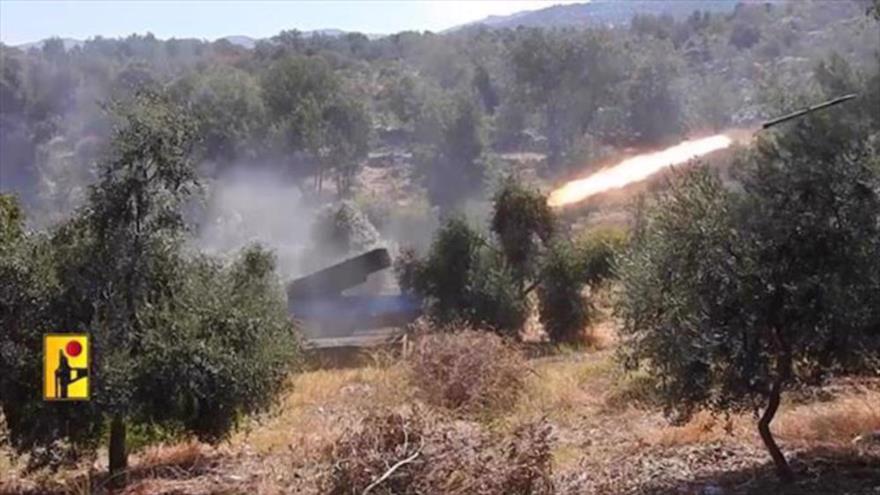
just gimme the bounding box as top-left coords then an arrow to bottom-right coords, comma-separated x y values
547,134 -> 733,207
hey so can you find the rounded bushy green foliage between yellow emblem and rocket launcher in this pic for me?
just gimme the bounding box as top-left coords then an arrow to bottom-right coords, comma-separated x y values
136,246 -> 299,440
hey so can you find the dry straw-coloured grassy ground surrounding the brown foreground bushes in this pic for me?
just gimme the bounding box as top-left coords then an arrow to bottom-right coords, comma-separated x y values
0,326 -> 880,495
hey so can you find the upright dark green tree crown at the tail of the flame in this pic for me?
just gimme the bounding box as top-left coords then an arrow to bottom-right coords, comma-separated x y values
491,176 -> 556,290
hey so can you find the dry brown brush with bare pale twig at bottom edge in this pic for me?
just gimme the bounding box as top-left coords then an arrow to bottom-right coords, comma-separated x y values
321,409 -> 553,495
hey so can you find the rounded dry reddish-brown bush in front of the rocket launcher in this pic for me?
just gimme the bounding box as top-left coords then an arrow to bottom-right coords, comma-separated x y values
408,330 -> 527,413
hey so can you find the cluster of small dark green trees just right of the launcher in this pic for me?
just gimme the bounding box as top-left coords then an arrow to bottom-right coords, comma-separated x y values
396,177 -> 624,342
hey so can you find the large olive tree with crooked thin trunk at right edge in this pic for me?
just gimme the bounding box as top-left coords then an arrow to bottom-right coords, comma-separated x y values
619,114 -> 880,479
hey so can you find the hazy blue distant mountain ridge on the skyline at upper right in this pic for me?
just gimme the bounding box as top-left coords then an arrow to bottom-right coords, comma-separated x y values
445,0 -> 740,32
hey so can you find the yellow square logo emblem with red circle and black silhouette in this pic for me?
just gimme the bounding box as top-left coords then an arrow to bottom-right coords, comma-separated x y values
43,333 -> 90,400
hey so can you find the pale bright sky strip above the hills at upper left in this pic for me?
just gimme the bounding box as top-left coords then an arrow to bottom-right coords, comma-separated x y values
0,0 -> 572,45
